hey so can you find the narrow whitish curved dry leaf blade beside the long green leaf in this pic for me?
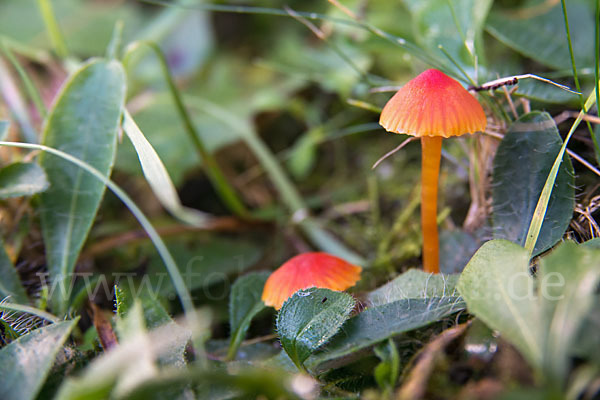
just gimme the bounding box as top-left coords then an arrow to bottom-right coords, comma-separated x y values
123,112 -> 208,226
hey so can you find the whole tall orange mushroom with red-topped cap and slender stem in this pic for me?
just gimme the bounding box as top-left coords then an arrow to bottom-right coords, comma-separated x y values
379,69 -> 486,273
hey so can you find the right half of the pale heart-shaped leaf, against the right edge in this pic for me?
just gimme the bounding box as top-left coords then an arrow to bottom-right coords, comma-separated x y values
537,242 -> 600,379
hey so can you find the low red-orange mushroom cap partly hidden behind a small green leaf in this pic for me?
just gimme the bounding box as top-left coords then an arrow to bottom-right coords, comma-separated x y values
262,252 -> 362,310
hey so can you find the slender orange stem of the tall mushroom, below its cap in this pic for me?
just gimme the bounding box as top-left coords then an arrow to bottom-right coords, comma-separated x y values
421,136 -> 442,274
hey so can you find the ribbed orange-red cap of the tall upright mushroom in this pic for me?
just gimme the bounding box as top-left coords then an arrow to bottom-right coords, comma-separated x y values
379,69 -> 486,137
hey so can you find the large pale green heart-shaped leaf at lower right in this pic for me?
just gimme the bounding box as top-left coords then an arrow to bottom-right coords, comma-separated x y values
458,240 -> 600,386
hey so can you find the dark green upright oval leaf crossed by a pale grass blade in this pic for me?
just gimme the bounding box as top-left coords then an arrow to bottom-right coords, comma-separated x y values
492,111 -> 575,255
